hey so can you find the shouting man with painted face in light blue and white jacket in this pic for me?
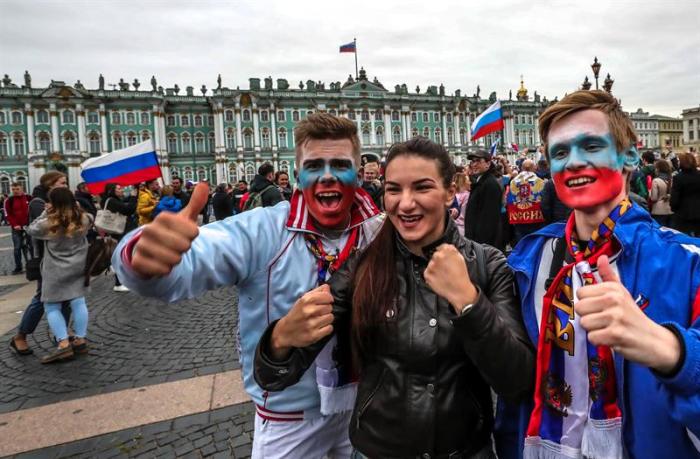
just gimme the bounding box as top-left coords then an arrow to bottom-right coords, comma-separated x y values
112,113 -> 381,459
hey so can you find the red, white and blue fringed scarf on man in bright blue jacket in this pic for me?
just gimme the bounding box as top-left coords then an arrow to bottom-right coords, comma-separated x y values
524,199 -> 631,459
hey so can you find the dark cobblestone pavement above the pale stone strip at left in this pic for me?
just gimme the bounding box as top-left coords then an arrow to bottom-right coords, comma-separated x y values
0,272 -> 240,413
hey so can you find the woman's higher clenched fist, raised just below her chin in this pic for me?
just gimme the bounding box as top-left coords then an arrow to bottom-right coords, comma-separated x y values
423,244 -> 478,314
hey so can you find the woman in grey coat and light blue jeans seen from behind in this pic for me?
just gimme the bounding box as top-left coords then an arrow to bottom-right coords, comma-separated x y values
27,188 -> 92,363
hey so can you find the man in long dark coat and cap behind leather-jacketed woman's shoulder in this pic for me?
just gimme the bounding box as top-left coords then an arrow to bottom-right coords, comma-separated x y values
464,150 -> 503,250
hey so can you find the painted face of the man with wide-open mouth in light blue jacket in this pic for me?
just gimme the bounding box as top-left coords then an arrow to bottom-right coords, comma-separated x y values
299,158 -> 357,229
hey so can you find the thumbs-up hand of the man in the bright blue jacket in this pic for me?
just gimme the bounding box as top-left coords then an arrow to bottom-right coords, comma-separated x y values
574,255 -> 681,373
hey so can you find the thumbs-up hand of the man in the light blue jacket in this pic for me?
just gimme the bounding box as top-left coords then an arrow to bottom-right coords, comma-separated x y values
131,183 -> 209,277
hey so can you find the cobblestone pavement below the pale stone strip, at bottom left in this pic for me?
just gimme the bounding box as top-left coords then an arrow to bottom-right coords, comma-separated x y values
8,403 -> 255,459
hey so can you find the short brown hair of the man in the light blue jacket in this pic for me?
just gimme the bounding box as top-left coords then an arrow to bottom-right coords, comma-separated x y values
294,113 -> 361,170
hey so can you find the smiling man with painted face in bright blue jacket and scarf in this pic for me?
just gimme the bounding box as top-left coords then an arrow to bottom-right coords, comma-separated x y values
509,91 -> 700,459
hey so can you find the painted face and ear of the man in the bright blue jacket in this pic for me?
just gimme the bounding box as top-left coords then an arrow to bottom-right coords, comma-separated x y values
548,110 -> 639,210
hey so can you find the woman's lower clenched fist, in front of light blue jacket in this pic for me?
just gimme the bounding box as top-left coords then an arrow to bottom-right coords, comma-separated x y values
270,285 -> 333,360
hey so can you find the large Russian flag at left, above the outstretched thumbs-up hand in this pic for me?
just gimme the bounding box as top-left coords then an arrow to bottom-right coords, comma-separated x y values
80,140 -> 162,194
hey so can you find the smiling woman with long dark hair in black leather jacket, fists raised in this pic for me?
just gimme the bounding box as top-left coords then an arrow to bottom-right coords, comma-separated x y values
255,138 -> 535,458
